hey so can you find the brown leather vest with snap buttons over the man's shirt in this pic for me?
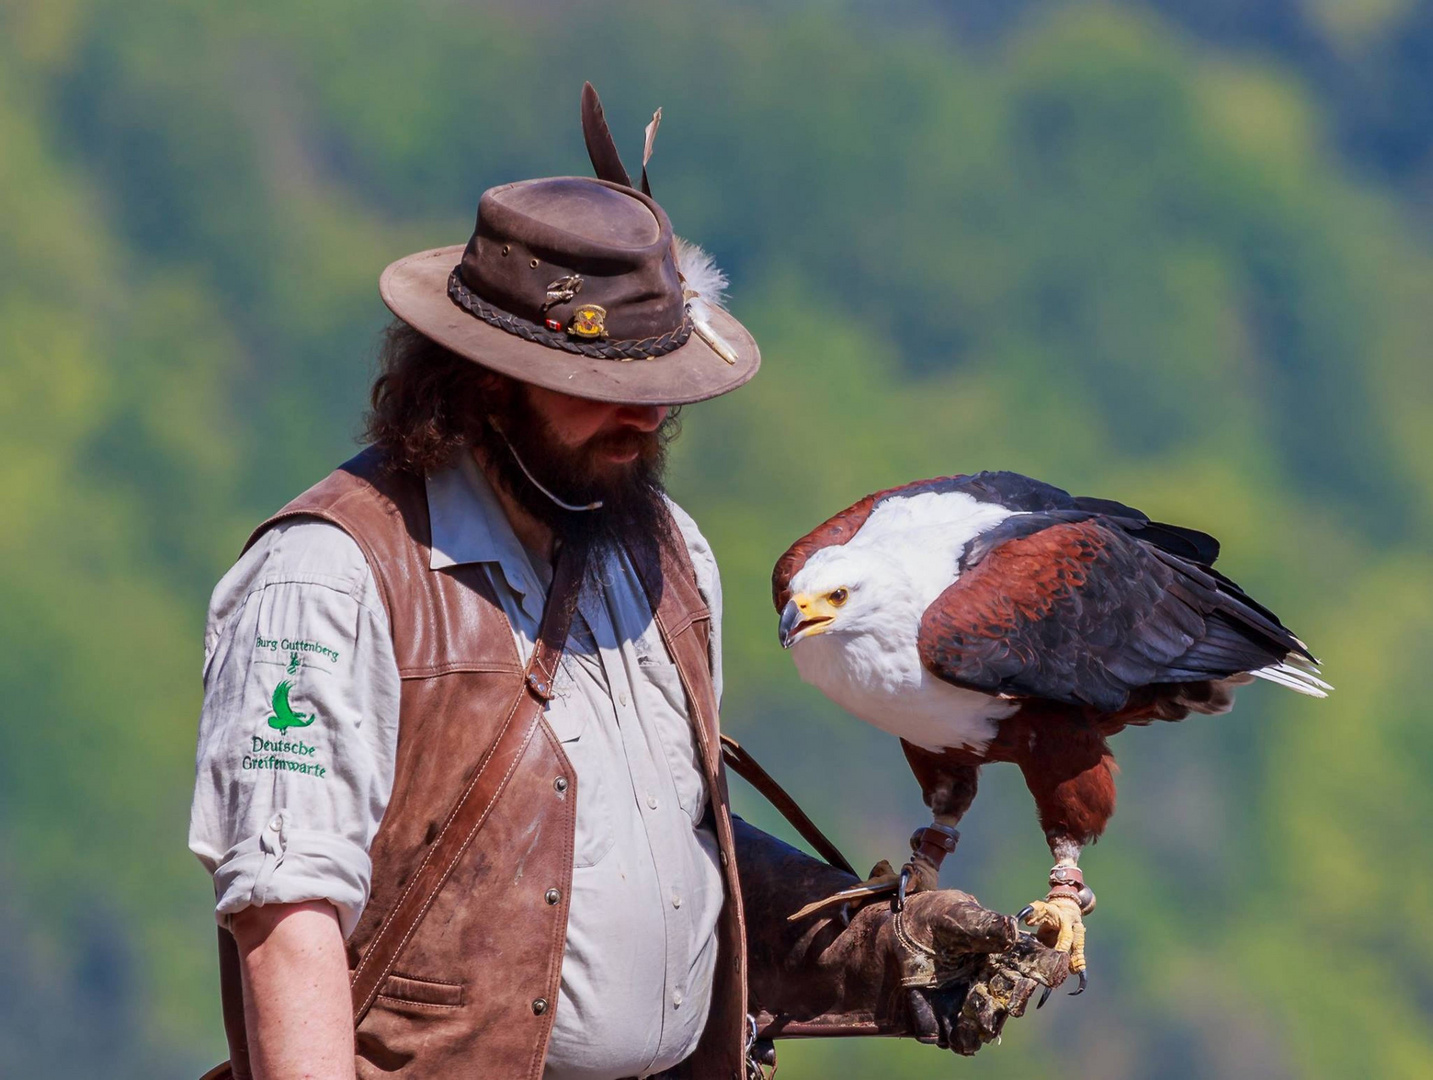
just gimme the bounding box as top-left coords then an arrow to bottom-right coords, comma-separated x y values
229,448 -> 747,1080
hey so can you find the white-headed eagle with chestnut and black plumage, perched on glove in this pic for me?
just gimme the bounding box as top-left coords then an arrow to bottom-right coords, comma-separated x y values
772,473 -> 1331,1004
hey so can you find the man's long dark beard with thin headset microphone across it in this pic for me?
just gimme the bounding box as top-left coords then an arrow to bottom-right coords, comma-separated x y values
470,385 -> 676,570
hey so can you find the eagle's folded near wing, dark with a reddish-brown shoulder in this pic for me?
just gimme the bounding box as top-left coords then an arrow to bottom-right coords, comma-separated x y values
919,511 -> 1313,713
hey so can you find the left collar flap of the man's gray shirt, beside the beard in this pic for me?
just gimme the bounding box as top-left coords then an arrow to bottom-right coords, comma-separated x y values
427,450 -> 545,617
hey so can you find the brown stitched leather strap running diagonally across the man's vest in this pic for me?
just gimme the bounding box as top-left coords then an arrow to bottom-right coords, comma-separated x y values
353,544 -> 588,1026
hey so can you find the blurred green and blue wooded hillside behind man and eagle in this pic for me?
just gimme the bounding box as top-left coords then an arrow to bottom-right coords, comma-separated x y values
0,0 -> 1433,1080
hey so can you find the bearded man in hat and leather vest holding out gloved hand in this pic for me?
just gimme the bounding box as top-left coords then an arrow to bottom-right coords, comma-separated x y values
191,92 -> 1063,1080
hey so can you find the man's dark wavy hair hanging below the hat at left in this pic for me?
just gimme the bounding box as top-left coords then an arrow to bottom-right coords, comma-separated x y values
364,319 -> 516,476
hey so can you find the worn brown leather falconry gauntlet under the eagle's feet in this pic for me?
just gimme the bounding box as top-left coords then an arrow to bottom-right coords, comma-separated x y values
734,818 -> 1068,1054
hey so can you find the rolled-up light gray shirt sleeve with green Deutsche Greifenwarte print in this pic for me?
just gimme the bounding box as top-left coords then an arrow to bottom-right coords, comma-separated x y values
189,520 -> 400,937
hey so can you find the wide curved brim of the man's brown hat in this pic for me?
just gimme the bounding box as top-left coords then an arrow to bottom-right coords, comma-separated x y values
378,245 -> 761,405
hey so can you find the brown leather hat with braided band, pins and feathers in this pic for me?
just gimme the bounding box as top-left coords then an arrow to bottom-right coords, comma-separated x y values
378,87 -> 761,404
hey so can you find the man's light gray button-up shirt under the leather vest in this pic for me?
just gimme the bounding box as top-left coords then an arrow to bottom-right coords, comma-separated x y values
189,454 -> 722,1080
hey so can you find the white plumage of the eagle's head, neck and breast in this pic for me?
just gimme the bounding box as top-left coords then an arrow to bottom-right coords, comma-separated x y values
791,491 -> 1019,751
